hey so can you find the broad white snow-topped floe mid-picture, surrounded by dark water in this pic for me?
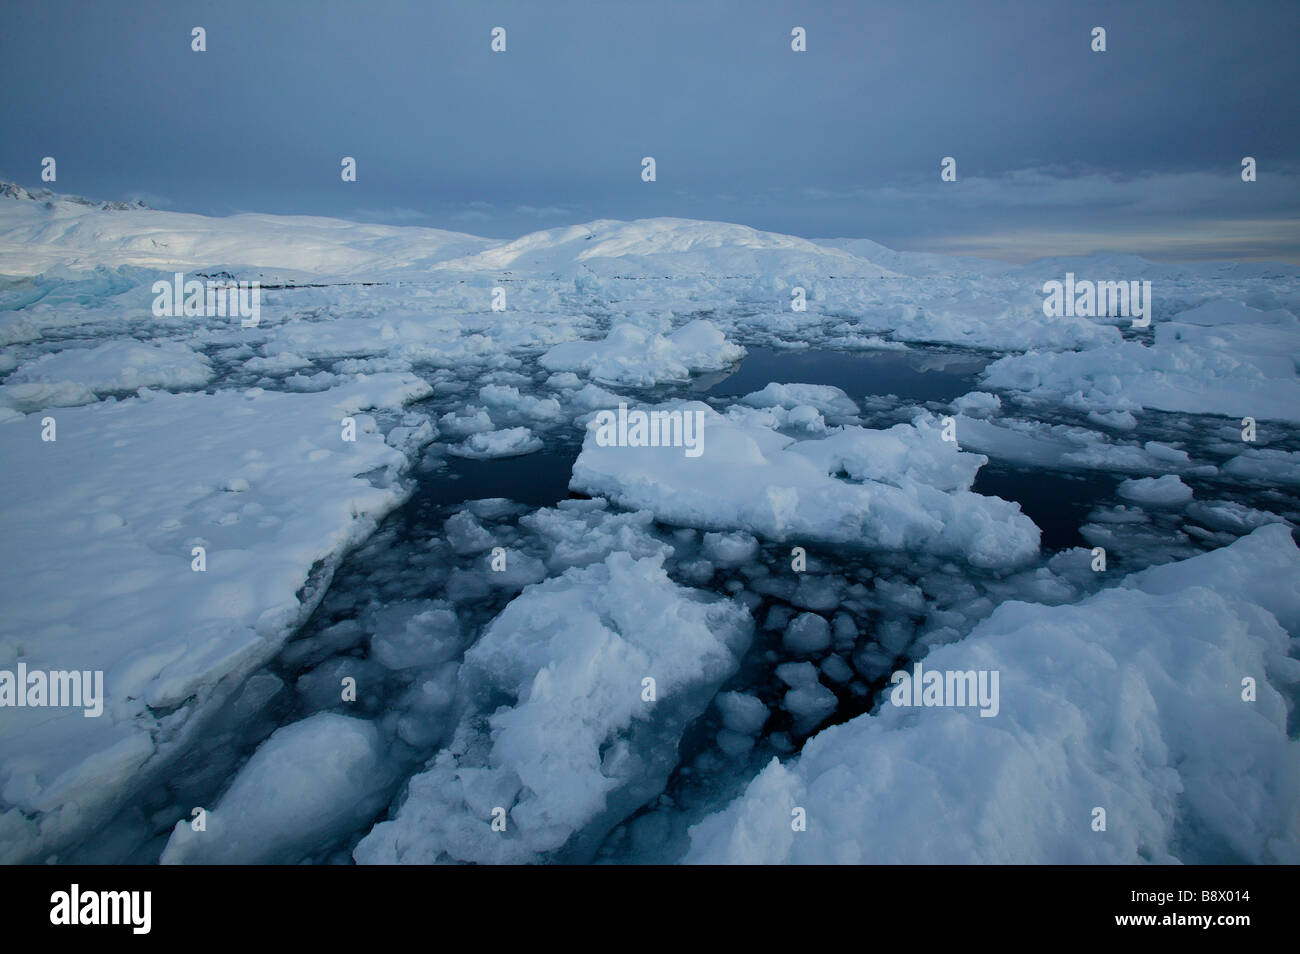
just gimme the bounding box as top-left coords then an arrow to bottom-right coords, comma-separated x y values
569,402 -> 1039,567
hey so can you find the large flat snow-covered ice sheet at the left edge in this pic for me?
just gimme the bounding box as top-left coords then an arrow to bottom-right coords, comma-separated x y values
0,376 -> 429,860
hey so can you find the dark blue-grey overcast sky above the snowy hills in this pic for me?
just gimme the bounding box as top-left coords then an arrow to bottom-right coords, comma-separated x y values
0,0 -> 1300,264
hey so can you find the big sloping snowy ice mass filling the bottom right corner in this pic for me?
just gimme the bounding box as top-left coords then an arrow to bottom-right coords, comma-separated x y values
688,526 -> 1300,864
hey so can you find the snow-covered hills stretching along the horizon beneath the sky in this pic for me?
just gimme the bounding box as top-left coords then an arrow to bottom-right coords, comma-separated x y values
0,182 -> 1300,293
